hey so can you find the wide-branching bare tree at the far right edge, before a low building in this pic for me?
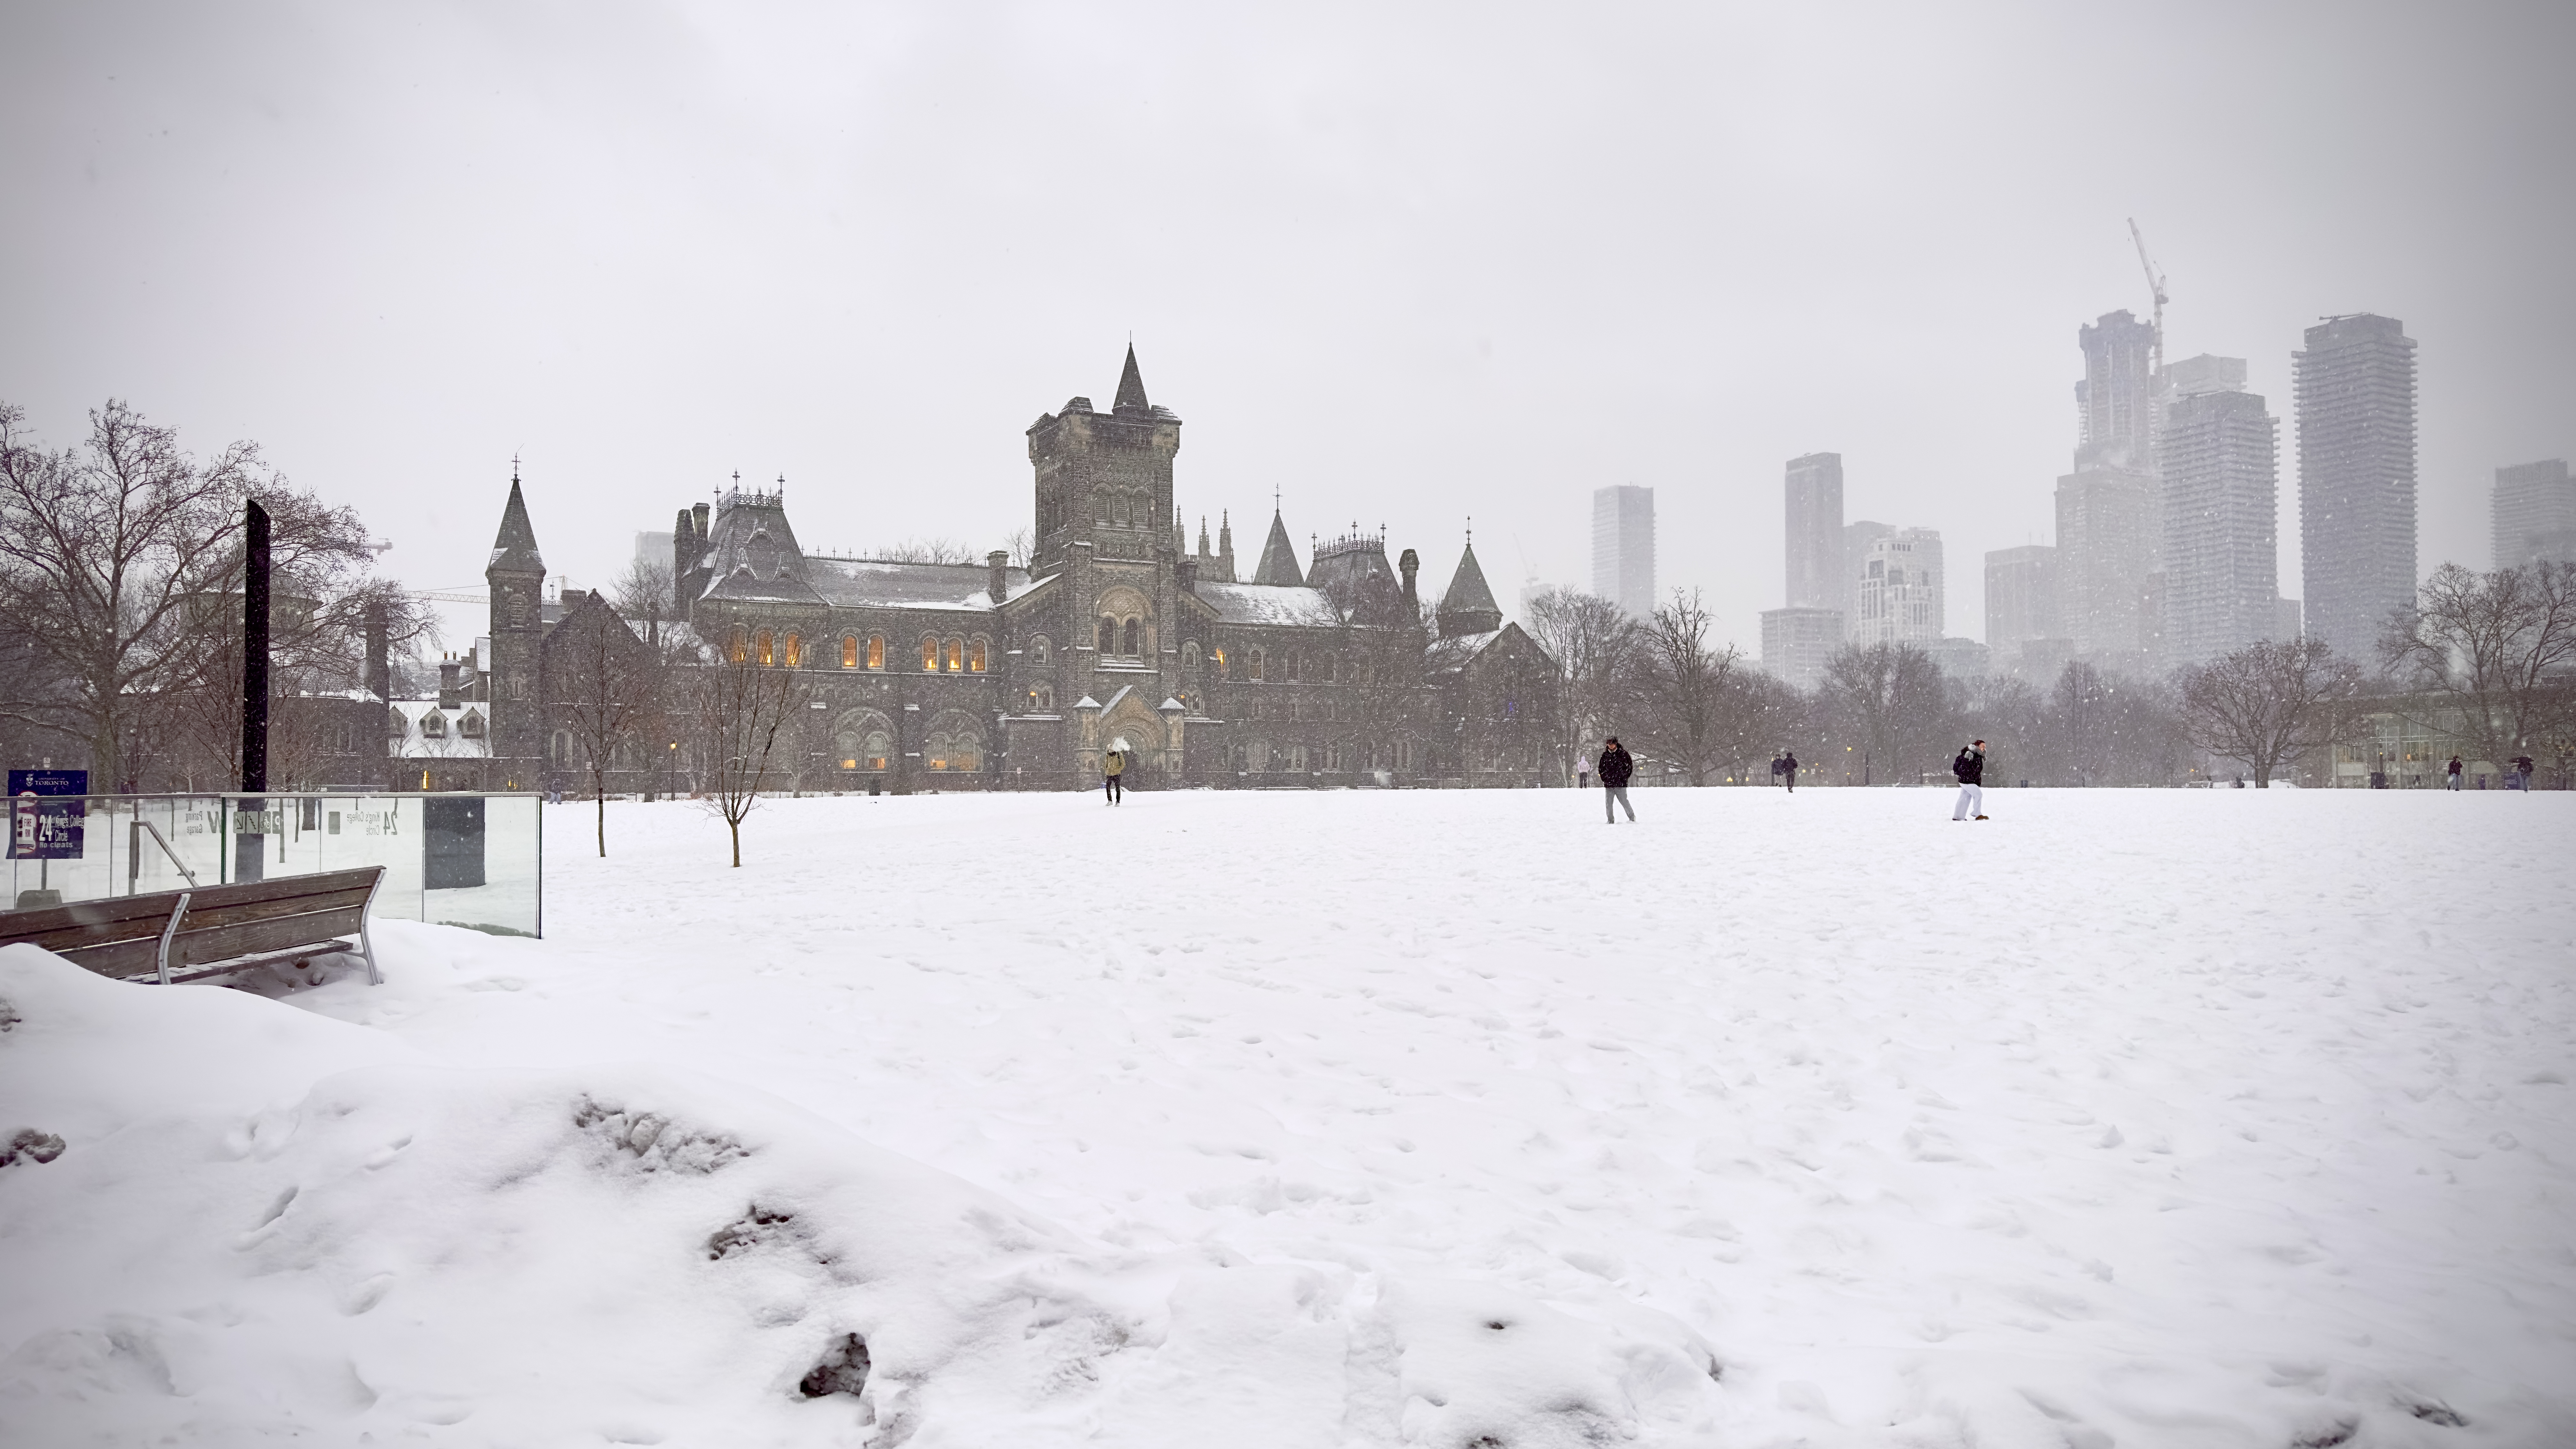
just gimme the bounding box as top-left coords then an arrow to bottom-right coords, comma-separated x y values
2380,559 -> 2576,766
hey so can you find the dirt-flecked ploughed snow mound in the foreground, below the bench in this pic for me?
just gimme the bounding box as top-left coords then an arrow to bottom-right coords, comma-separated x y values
0,946 -> 1721,1449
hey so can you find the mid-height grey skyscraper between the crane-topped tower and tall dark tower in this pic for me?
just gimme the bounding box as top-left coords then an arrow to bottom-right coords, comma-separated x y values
2164,384 -> 2280,665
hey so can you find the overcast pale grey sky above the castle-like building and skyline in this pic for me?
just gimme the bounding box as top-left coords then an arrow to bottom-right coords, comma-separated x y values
0,3 -> 2576,647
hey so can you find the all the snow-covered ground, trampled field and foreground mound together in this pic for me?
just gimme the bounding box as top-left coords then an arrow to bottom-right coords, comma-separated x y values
0,789 -> 2576,1449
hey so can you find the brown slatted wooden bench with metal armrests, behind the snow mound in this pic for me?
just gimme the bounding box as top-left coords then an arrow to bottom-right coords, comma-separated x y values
0,866 -> 384,985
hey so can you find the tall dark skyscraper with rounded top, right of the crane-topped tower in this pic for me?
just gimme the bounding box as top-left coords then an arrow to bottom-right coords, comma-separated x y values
2290,312 -> 2416,660
